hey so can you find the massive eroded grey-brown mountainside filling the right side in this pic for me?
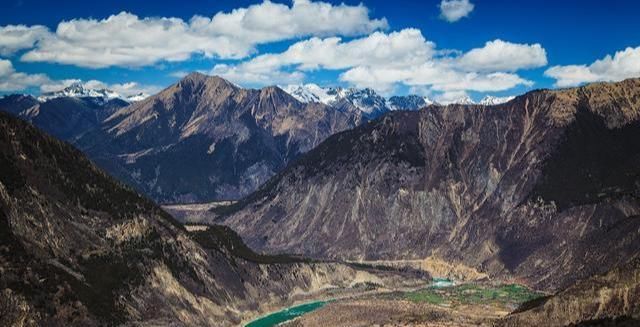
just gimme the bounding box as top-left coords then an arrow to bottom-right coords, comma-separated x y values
220,79 -> 640,289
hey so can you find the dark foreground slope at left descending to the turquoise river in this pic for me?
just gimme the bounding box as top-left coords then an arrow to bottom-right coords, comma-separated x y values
0,113 -> 430,326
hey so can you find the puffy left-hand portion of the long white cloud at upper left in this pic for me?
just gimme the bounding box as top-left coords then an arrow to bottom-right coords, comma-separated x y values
22,12 -> 249,68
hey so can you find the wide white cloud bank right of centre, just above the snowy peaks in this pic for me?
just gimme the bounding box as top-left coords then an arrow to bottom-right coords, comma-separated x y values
211,28 -> 547,93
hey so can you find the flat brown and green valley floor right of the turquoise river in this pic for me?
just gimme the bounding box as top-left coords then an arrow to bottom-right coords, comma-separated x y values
283,282 -> 544,327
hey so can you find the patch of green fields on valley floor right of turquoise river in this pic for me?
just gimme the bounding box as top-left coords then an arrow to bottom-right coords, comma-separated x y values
403,284 -> 543,306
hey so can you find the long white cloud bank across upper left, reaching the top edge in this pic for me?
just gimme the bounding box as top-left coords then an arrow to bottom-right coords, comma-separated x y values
11,0 -> 388,68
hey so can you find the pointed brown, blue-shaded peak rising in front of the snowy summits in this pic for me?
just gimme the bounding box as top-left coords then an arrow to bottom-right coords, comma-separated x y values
75,73 -> 365,203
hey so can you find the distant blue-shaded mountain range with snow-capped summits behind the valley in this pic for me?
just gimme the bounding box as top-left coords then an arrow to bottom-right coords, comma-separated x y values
0,73 -> 508,203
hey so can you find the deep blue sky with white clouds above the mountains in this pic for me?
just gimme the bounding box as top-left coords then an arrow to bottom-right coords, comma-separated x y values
0,0 -> 640,102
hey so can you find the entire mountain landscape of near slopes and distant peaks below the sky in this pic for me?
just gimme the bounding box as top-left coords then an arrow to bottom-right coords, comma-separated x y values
0,73 -> 640,326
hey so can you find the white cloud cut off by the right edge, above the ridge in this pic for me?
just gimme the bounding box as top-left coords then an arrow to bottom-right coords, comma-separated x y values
544,47 -> 640,87
